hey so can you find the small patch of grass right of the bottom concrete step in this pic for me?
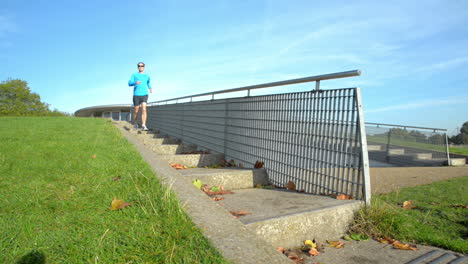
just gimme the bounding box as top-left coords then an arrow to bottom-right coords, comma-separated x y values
351,176 -> 468,253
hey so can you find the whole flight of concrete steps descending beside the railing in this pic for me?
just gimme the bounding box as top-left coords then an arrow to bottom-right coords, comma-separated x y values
124,125 -> 362,247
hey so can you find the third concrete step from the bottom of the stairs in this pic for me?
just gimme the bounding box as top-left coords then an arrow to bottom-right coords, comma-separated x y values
158,153 -> 224,167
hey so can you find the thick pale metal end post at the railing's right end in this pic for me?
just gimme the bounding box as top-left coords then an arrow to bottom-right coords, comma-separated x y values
355,88 -> 371,205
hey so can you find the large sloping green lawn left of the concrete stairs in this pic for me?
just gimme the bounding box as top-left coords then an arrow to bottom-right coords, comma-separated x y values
0,117 -> 226,263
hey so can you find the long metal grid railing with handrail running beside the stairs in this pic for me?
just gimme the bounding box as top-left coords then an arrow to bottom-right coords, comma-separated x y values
147,70 -> 370,202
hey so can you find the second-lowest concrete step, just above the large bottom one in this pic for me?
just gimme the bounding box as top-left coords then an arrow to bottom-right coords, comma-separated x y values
179,168 -> 269,190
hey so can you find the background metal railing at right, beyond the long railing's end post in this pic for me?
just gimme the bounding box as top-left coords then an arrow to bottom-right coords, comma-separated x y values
365,122 -> 450,167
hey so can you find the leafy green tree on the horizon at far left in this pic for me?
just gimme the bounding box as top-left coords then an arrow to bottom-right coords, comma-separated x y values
0,79 -> 66,116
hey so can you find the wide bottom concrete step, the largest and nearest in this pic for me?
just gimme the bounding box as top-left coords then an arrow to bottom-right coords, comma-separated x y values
212,189 -> 362,248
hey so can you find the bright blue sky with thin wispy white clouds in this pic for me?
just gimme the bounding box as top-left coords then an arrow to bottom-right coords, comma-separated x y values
0,0 -> 468,134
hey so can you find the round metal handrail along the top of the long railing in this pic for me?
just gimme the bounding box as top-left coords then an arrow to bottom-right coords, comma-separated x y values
149,70 -> 361,104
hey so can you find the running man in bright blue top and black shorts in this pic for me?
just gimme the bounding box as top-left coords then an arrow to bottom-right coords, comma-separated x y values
128,62 -> 153,131
